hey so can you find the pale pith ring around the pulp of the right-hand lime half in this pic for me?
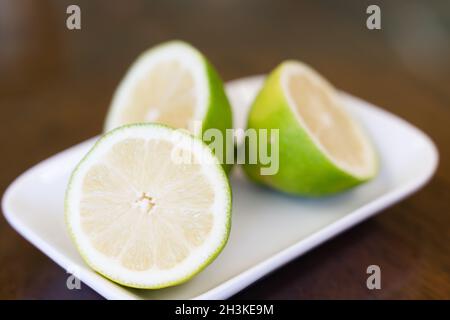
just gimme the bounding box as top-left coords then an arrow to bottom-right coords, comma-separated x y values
280,61 -> 376,179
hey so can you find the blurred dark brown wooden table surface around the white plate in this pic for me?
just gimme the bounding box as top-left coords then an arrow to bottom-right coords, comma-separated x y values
0,0 -> 450,299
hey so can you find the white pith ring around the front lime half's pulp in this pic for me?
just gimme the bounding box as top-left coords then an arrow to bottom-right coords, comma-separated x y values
66,125 -> 230,287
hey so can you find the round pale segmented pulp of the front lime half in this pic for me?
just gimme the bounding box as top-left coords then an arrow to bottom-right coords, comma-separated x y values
80,138 -> 214,271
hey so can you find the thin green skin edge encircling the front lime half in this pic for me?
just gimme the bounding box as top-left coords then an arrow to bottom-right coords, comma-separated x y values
64,123 -> 232,289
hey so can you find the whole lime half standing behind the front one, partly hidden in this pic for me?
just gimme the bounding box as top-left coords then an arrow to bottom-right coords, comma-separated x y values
105,41 -> 232,170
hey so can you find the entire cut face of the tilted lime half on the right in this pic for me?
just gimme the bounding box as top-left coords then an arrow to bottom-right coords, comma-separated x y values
281,62 -> 375,178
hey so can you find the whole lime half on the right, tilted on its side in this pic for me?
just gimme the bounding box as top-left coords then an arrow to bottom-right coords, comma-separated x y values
244,61 -> 377,196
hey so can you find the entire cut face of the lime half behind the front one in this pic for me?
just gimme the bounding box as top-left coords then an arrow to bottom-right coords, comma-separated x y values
105,42 -> 210,131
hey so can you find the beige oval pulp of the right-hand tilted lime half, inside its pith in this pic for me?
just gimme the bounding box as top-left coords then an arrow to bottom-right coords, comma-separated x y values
287,65 -> 368,175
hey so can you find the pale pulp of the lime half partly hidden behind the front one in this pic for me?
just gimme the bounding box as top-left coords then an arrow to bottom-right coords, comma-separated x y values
120,60 -> 197,129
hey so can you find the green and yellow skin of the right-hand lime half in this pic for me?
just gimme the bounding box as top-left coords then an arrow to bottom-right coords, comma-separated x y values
243,63 -> 375,196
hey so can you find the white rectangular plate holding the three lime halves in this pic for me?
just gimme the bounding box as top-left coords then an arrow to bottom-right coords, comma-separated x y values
2,77 -> 438,299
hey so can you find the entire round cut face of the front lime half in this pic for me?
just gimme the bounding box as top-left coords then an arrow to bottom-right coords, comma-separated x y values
66,124 -> 231,288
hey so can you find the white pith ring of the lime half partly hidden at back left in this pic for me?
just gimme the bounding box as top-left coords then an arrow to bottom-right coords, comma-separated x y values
105,41 -> 209,133
